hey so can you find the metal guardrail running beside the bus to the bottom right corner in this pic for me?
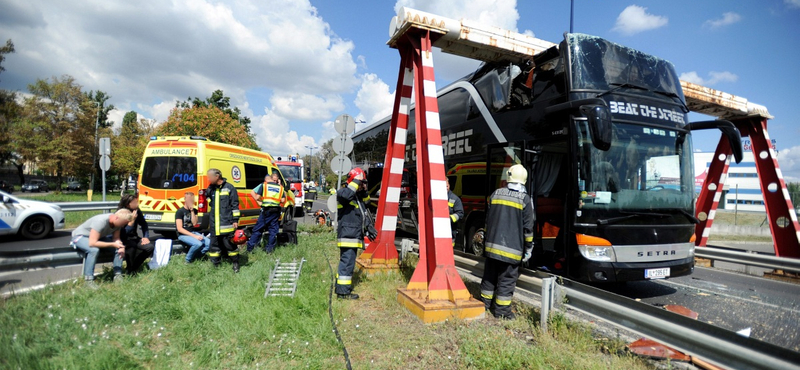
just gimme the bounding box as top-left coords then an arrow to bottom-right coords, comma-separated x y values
455,254 -> 800,370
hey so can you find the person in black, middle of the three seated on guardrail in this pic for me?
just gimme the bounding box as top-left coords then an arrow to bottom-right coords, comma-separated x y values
117,194 -> 156,275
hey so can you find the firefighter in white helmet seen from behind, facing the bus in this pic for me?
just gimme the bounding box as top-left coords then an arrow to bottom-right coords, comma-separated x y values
481,164 -> 534,319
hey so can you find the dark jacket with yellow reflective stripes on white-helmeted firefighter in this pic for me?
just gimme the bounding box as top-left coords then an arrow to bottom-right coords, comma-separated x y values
484,188 -> 534,264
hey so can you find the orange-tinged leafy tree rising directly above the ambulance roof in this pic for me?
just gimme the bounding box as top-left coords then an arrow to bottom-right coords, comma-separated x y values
155,106 -> 259,150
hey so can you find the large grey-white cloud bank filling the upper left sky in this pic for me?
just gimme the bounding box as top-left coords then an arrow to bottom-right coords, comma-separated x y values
0,0 -> 359,124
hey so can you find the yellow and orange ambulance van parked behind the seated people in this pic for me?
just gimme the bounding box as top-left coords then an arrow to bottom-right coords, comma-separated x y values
138,136 -> 294,237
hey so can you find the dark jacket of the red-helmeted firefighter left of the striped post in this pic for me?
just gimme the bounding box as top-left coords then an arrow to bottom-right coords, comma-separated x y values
336,180 -> 372,248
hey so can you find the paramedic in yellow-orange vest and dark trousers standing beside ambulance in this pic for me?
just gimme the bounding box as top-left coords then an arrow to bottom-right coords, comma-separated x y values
247,170 -> 286,253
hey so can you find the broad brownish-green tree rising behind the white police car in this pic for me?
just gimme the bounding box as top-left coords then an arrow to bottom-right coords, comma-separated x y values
10,75 -> 96,188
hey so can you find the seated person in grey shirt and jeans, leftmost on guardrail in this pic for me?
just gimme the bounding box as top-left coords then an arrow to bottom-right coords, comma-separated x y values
70,209 -> 134,289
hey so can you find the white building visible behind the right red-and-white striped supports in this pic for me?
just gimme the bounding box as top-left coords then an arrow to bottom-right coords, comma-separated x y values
694,148 -> 766,212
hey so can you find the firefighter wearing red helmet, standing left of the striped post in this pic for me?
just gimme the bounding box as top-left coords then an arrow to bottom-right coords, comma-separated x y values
336,167 -> 378,299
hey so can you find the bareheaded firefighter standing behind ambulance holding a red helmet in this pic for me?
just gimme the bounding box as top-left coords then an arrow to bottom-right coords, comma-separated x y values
206,168 -> 240,272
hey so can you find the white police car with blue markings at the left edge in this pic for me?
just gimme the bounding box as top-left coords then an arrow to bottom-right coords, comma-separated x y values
0,191 -> 64,239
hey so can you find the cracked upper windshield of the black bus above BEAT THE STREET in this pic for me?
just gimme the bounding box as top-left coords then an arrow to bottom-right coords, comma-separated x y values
567,33 -> 684,100
